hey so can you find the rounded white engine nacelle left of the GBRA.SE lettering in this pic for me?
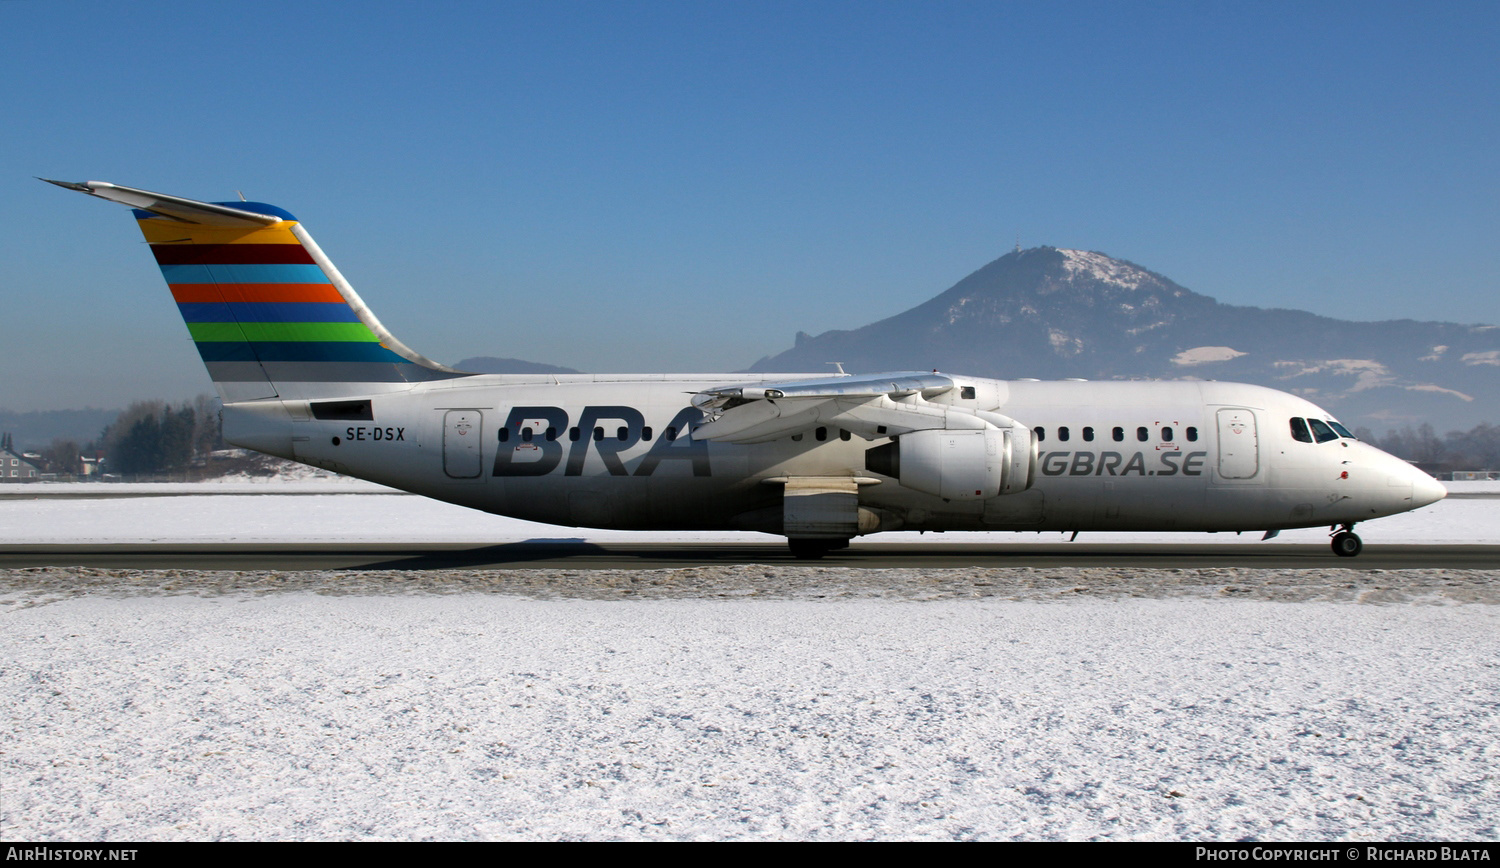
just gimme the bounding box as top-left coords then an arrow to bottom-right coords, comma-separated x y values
866,426 -> 1037,501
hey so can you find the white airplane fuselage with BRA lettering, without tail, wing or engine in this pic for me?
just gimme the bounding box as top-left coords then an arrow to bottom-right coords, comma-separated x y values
224,375 -> 1445,532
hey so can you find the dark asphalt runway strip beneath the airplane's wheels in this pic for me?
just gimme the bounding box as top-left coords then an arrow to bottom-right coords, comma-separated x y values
0,540 -> 1500,571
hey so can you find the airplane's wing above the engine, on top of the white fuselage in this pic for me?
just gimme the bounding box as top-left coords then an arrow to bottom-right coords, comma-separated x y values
693,372 -> 1011,444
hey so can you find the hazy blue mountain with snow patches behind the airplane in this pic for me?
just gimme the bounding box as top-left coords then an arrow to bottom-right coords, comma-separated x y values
750,247 -> 1500,430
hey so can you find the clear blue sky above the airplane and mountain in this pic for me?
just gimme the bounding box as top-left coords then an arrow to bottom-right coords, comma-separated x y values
0,0 -> 1500,409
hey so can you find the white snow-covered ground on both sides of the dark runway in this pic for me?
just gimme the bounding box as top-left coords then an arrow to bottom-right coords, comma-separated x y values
0,483 -> 1500,841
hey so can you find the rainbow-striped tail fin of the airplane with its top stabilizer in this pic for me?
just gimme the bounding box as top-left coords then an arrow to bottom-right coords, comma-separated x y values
42,178 -> 465,403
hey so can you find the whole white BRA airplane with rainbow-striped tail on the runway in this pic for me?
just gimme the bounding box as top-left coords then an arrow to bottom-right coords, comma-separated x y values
42,178 -> 1448,558
